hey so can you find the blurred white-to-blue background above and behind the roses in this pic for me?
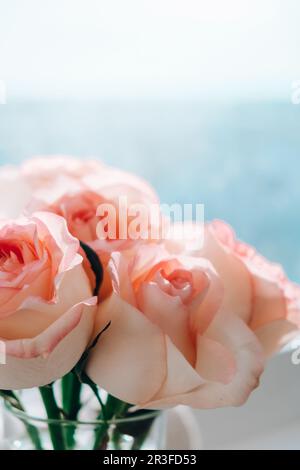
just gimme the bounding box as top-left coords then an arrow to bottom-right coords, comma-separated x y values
0,0 -> 300,281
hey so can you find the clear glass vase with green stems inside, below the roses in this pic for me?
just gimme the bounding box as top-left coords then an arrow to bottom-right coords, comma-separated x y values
3,403 -> 165,450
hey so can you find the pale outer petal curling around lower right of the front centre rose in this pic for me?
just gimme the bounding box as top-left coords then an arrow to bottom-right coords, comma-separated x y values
140,313 -> 264,409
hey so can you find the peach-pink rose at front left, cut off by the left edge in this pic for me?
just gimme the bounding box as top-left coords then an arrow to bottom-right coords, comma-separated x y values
0,212 -> 96,389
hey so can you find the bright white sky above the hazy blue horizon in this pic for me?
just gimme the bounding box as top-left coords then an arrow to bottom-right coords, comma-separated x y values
0,0 -> 300,99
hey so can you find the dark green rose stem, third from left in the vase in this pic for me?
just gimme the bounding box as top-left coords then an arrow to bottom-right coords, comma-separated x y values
61,372 -> 82,449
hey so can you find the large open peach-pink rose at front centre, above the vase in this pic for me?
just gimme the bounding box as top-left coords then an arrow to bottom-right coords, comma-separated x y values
87,244 -> 264,408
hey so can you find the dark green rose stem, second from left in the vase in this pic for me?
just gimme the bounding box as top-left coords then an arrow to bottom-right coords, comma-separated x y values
39,385 -> 66,450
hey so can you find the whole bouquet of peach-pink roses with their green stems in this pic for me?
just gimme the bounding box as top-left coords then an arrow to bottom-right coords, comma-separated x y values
0,157 -> 300,449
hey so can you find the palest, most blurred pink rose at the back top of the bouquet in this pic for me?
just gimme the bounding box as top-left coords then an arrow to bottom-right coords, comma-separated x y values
0,155 -> 158,217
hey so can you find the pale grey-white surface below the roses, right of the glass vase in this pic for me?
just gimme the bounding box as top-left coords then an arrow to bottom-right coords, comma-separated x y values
195,352 -> 300,449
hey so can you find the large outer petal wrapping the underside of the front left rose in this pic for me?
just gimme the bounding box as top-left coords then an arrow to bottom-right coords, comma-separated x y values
0,298 -> 96,390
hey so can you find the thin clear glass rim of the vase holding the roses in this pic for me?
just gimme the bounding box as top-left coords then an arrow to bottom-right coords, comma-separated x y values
5,402 -> 161,426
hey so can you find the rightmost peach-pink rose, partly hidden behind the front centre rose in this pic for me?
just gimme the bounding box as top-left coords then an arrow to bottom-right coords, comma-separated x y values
167,220 -> 300,355
